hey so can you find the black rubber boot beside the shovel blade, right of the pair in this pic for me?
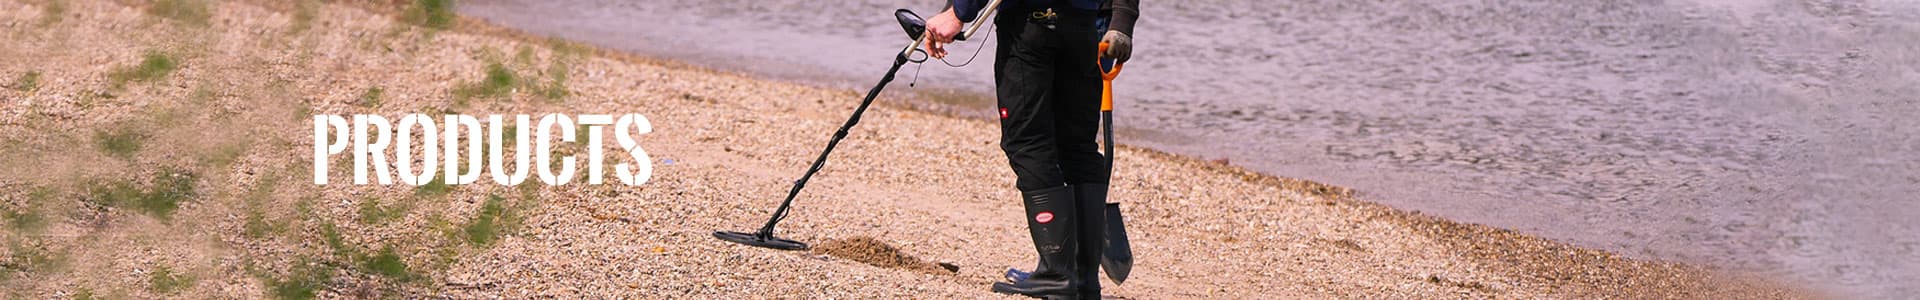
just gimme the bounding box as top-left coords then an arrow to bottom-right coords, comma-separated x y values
1073,183 -> 1106,298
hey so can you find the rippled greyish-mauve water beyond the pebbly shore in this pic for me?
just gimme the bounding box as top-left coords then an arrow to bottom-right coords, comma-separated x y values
461,0 -> 1920,298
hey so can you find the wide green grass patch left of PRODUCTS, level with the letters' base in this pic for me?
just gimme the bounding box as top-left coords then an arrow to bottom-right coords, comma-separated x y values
88,167 -> 200,219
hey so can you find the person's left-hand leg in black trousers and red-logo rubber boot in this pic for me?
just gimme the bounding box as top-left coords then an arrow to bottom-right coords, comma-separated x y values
993,11 -> 1081,298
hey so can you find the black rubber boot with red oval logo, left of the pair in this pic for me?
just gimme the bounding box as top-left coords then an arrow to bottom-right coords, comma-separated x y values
993,187 -> 1081,298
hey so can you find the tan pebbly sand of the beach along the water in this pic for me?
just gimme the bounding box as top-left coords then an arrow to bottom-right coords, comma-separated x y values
0,0 -> 1814,298
